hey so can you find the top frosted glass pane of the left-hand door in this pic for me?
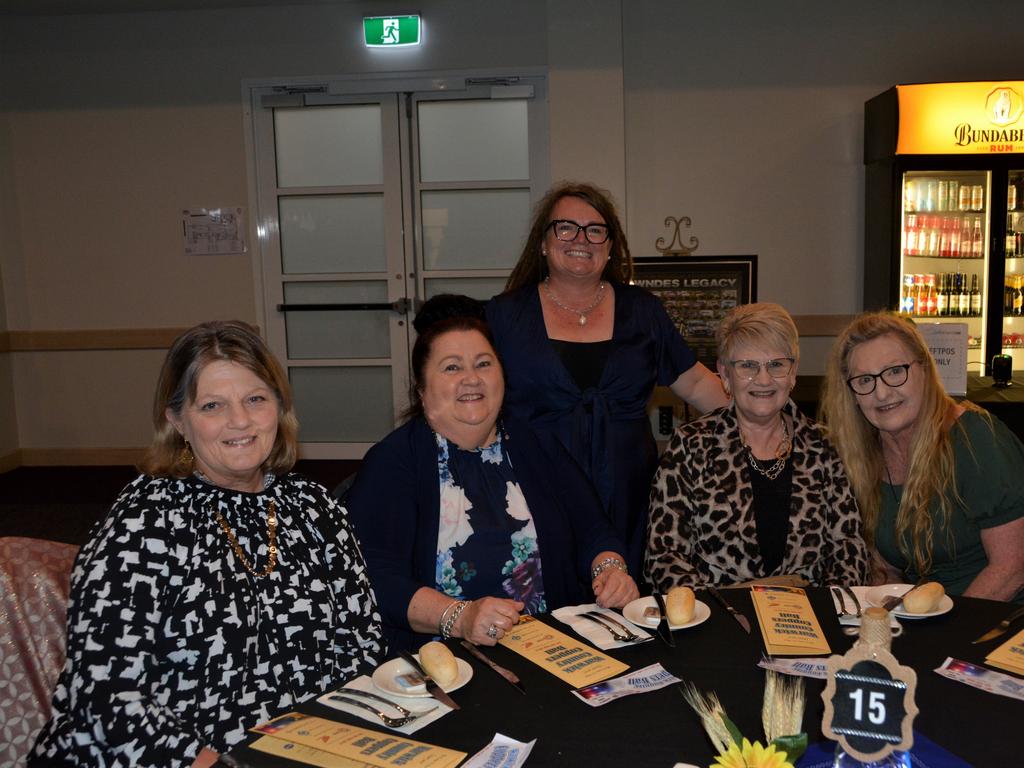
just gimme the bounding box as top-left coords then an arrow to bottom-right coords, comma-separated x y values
273,104 -> 384,186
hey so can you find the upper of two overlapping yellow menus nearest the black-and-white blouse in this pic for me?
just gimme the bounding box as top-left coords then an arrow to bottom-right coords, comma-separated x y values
252,712 -> 466,768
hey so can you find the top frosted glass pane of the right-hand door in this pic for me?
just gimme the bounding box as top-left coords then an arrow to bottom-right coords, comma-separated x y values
418,98 -> 529,182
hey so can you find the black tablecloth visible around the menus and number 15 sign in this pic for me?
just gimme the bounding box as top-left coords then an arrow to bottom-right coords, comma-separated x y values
231,589 -> 1024,768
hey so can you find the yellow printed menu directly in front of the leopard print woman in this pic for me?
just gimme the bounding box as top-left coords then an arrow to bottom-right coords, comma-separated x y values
751,585 -> 831,656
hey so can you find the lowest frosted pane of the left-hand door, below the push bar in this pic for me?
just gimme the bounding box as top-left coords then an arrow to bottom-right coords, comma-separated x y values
289,368 -> 394,442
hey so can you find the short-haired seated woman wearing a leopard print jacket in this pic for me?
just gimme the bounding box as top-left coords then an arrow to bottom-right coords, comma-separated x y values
645,303 -> 867,592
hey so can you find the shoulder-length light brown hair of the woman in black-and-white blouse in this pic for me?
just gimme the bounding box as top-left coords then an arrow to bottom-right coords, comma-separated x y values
138,321 -> 299,477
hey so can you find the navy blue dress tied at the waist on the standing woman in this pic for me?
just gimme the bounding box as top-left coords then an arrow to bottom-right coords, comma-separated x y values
486,284 -> 696,574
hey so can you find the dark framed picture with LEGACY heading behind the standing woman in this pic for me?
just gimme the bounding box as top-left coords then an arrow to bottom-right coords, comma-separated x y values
633,256 -> 758,371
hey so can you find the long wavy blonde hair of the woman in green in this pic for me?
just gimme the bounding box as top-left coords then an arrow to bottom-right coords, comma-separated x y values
819,312 -> 980,575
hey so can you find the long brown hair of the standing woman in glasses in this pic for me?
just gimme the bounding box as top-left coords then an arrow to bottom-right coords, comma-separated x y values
505,181 -> 633,293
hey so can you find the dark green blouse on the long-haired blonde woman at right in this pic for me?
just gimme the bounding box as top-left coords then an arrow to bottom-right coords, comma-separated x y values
874,411 -> 1024,600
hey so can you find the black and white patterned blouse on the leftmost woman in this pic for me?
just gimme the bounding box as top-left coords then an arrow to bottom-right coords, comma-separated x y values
30,475 -> 384,768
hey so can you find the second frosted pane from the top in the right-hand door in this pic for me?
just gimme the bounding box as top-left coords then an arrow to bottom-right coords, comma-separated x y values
421,189 -> 529,269
